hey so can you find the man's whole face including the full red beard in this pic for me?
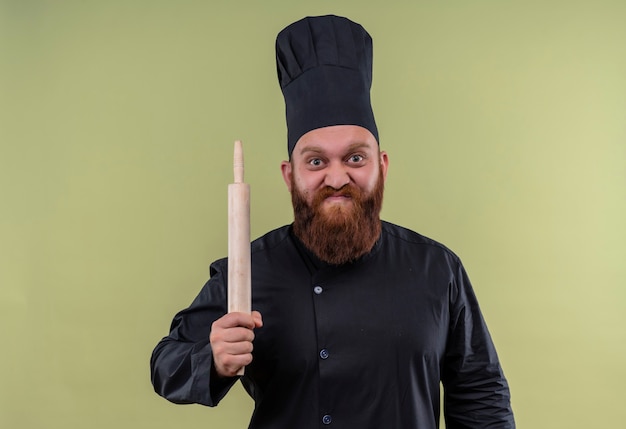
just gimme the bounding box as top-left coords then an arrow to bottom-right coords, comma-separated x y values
282,126 -> 388,265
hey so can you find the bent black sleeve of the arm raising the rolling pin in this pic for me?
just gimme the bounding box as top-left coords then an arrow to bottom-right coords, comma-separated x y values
150,259 -> 238,406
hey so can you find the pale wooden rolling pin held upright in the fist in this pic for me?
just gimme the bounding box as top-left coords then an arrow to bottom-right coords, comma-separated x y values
228,140 -> 252,375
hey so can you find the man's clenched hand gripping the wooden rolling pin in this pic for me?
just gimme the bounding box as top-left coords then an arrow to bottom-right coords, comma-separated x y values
209,311 -> 263,377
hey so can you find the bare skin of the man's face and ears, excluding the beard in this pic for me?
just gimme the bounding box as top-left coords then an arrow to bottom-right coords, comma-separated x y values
281,125 -> 389,209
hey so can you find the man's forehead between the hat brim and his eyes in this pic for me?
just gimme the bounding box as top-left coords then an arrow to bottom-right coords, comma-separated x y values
293,125 -> 378,157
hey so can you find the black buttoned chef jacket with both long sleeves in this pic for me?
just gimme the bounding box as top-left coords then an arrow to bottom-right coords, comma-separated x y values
151,222 -> 515,429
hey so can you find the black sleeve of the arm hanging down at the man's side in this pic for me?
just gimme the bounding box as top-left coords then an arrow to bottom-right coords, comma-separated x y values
442,262 -> 515,429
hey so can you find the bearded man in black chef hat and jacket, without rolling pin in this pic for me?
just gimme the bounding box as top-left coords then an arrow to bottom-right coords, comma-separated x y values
151,16 -> 515,429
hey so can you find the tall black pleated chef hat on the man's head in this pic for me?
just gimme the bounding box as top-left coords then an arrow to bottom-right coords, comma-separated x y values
276,15 -> 378,157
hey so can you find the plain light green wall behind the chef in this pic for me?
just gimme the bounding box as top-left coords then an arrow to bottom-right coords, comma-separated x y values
0,0 -> 626,429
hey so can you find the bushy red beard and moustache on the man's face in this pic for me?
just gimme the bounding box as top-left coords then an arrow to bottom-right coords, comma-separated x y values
291,169 -> 384,265
